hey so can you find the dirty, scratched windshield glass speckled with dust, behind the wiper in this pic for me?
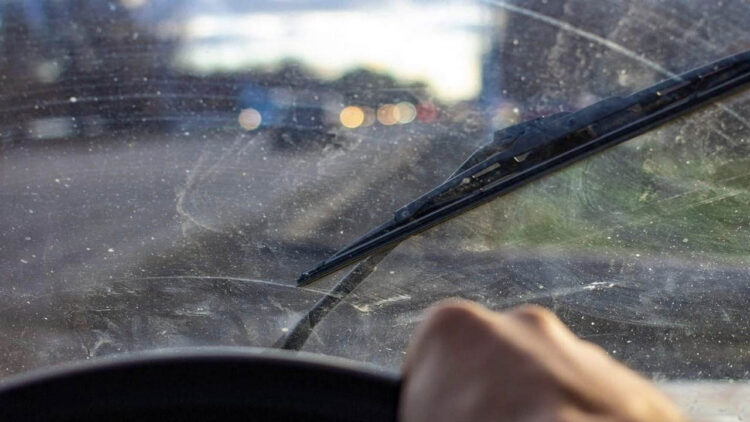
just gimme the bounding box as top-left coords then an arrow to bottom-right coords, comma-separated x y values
0,0 -> 750,417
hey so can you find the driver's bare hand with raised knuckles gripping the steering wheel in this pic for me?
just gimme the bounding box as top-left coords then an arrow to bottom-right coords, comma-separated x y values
399,301 -> 686,422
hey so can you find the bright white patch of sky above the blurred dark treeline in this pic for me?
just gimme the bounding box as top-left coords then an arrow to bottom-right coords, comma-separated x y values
167,0 -> 489,101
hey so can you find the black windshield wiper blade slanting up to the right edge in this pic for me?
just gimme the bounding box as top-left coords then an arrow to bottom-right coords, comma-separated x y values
297,51 -> 750,286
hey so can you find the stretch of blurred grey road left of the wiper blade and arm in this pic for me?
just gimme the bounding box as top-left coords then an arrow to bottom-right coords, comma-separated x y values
0,123 -> 478,373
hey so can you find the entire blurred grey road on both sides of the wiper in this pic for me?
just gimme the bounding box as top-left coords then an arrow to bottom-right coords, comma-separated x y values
0,126 -> 750,378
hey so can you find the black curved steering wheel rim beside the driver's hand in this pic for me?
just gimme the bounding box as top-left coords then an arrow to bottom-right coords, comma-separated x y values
0,349 -> 400,422
